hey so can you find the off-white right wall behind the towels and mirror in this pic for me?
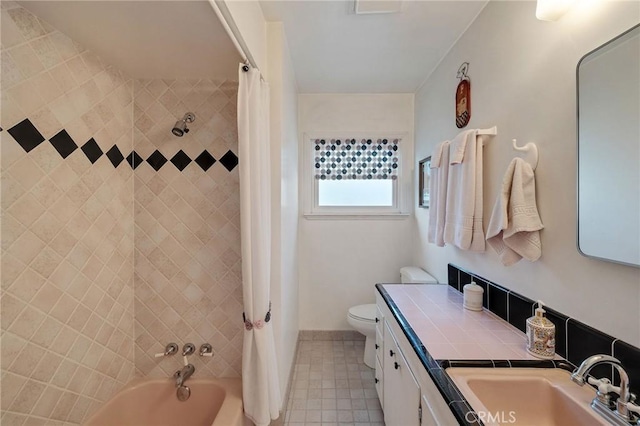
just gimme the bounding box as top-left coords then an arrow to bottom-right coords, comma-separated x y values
413,1 -> 640,345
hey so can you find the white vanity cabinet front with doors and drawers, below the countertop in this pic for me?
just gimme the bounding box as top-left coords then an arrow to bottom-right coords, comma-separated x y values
375,292 -> 458,426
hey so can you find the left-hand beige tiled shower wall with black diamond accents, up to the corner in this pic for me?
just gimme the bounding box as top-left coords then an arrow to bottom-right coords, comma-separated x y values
0,1 -> 134,425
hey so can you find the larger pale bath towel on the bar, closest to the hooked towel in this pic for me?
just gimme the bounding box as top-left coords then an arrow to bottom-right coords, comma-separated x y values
444,129 -> 485,252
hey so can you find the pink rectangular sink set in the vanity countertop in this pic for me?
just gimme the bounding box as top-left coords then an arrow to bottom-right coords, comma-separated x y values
446,367 -> 608,426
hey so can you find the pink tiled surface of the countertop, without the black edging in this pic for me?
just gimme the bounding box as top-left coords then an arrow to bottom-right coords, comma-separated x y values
382,284 -> 563,360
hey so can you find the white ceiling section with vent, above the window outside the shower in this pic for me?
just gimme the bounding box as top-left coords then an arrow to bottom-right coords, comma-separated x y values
260,0 -> 487,93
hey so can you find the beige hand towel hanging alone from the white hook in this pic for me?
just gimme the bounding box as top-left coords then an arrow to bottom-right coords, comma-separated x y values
487,158 -> 544,266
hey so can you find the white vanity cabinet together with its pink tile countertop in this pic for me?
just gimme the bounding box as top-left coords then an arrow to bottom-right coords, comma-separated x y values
375,284 -> 562,426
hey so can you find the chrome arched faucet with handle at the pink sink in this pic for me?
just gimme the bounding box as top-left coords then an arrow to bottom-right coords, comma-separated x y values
571,355 -> 635,425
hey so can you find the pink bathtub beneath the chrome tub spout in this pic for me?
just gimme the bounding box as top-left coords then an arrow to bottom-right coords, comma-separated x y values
85,379 -> 251,426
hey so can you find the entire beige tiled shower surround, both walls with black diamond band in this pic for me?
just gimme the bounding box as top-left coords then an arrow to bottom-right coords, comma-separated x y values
0,1 -> 242,425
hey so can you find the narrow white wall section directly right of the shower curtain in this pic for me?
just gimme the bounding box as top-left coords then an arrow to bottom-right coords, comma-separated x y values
267,22 -> 298,403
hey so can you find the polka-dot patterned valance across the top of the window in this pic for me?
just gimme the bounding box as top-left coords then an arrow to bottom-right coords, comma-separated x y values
312,138 -> 400,180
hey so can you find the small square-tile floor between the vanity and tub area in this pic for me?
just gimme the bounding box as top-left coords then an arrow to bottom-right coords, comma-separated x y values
284,340 -> 384,426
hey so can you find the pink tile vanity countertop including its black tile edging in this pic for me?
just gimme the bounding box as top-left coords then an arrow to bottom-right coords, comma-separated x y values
376,284 -> 575,426
